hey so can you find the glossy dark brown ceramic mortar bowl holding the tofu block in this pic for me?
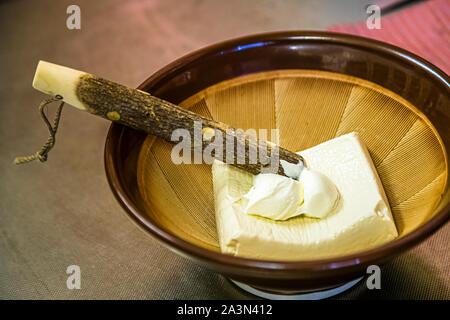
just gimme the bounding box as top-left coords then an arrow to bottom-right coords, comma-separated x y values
105,32 -> 450,292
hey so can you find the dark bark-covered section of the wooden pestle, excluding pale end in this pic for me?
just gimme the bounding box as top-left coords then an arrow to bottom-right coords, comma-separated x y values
76,74 -> 303,176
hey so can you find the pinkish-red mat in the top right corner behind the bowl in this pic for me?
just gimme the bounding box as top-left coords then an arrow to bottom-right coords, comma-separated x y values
328,0 -> 450,74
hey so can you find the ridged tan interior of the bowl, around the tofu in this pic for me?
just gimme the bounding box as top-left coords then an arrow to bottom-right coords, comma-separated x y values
137,69 -> 448,255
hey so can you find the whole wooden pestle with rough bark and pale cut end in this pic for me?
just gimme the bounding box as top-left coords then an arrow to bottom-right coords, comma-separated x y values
33,61 -> 303,175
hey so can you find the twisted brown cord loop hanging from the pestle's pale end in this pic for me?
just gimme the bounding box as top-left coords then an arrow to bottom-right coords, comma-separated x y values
14,95 -> 64,164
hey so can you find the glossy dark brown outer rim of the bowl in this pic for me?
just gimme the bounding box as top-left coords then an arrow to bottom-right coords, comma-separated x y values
104,31 -> 450,272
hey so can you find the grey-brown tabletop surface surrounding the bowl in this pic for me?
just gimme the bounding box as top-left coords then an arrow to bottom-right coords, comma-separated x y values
0,0 -> 450,299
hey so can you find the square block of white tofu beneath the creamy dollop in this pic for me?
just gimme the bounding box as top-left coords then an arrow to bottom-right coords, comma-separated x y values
212,133 -> 398,260
